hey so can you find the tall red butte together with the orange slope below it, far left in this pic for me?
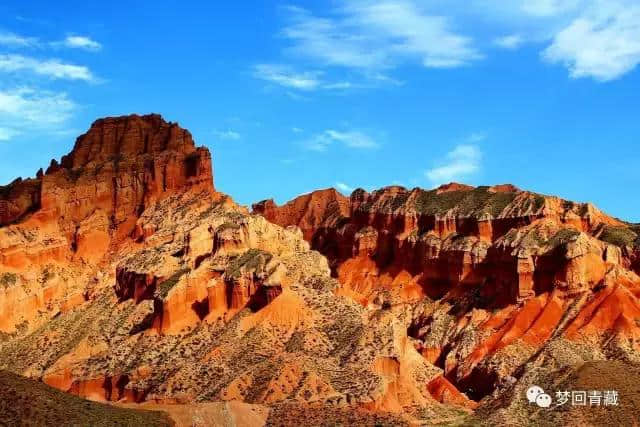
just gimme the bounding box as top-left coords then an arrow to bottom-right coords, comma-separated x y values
0,115 -> 214,333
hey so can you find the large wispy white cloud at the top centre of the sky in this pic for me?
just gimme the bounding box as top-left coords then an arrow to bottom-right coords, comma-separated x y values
282,0 -> 482,70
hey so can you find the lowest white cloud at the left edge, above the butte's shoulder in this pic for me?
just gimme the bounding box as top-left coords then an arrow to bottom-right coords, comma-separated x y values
0,87 -> 77,140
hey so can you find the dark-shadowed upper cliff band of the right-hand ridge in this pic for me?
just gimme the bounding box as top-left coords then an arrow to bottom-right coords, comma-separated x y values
254,183 -> 623,306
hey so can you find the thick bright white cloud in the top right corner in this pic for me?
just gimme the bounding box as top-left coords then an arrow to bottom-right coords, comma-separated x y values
482,0 -> 640,82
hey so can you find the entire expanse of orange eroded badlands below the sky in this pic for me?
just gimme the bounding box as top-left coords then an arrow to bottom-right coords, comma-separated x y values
0,115 -> 640,426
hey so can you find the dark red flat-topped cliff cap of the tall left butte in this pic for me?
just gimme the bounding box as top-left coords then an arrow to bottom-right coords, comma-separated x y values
0,114 -> 213,239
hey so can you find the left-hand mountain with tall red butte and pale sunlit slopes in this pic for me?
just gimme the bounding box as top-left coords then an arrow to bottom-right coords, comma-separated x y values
0,115 -> 475,423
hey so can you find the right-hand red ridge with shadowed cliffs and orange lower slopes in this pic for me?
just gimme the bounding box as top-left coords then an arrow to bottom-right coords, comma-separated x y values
253,184 -> 640,410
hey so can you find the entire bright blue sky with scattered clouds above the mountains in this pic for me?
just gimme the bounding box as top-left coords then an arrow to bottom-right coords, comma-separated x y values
0,0 -> 640,221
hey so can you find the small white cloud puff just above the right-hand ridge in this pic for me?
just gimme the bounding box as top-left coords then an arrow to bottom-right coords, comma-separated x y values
425,144 -> 482,185
